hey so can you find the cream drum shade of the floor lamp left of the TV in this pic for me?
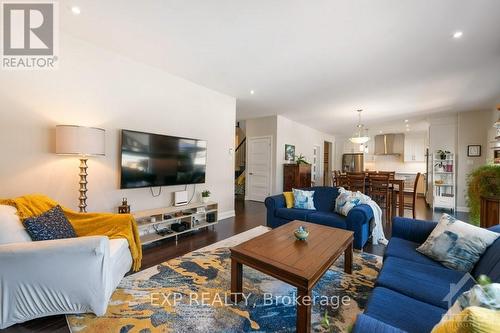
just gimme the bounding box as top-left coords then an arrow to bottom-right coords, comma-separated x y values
56,125 -> 106,156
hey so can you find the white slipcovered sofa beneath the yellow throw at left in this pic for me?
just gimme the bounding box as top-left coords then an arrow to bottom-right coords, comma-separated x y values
0,205 -> 132,329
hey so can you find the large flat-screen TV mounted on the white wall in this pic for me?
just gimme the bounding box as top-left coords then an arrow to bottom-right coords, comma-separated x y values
120,130 -> 207,189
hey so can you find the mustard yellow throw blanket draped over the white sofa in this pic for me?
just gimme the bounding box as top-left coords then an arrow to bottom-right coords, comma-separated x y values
0,194 -> 142,271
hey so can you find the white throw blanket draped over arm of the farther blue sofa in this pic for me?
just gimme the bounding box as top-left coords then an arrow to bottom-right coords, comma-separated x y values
335,187 -> 388,245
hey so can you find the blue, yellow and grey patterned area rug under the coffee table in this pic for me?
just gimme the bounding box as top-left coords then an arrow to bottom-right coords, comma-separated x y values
67,228 -> 382,333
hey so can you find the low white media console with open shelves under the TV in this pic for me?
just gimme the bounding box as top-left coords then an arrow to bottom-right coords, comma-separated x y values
132,202 -> 219,245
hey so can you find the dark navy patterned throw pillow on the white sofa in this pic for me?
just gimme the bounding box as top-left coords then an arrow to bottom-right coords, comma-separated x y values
23,205 -> 77,241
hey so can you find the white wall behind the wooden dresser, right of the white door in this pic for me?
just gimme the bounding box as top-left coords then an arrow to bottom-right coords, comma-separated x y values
273,115 -> 335,193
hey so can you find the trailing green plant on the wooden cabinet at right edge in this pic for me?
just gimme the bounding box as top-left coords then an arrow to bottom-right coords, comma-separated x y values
467,165 -> 500,225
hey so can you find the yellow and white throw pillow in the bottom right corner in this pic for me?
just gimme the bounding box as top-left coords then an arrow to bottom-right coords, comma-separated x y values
432,306 -> 500,333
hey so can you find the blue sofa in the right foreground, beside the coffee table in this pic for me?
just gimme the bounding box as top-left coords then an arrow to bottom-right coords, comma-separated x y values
353,217 -> 500,333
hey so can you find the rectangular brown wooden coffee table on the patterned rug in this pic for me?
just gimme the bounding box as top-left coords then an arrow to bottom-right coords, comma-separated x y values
231,221 -> 354,333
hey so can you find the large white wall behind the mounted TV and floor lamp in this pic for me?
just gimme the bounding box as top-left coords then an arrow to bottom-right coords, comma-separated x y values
0,34 -> 236,215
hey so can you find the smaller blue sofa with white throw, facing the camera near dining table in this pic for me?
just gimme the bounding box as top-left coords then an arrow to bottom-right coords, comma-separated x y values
265,186 -> 373,249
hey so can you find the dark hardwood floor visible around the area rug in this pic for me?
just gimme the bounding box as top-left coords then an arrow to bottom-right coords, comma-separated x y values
0,198 -> 460,333
